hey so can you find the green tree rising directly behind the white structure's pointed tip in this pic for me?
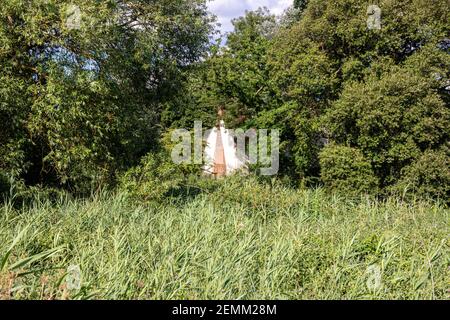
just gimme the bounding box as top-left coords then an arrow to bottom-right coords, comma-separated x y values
171,9 -> 276,127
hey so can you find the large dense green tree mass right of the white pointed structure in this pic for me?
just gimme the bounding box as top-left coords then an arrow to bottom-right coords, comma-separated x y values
259,0 -> 449,192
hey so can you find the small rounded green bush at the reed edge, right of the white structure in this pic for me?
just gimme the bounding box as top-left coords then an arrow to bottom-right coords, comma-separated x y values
320,144 -> 378,194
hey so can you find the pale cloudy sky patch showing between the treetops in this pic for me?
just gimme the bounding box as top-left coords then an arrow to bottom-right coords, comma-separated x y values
208,0 -> 294,33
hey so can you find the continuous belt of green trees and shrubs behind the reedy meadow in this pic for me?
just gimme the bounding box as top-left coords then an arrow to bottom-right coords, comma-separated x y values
0,0 -> 450,198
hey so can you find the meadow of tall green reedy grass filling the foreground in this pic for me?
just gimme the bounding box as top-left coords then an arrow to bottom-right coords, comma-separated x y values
0,179 -> 450,299
